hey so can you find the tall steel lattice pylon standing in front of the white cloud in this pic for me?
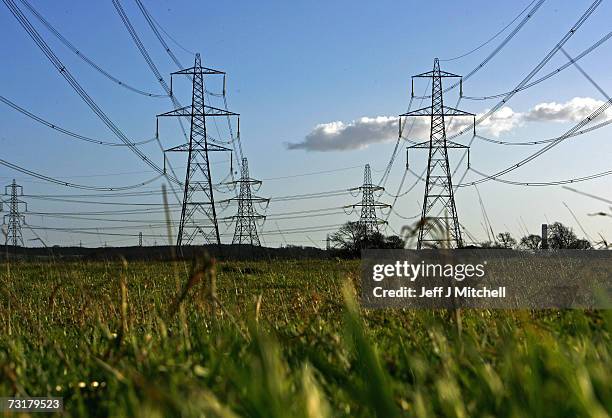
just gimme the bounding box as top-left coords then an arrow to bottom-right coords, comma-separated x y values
400,58 -> 476,249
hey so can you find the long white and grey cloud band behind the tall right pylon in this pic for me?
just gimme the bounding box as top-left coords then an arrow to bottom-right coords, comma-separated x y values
287,97 -> 612,151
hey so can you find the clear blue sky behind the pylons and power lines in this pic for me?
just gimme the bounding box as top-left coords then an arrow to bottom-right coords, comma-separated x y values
0,0 -> 612,245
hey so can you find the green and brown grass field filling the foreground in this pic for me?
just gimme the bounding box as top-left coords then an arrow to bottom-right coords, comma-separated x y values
0,258 -> 612,418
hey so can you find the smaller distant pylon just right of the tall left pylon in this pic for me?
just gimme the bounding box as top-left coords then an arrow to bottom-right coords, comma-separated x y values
222,158 -> 270,246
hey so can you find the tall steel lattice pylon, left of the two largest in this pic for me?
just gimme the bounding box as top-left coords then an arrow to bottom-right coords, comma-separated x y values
157,54 -> 239,247
